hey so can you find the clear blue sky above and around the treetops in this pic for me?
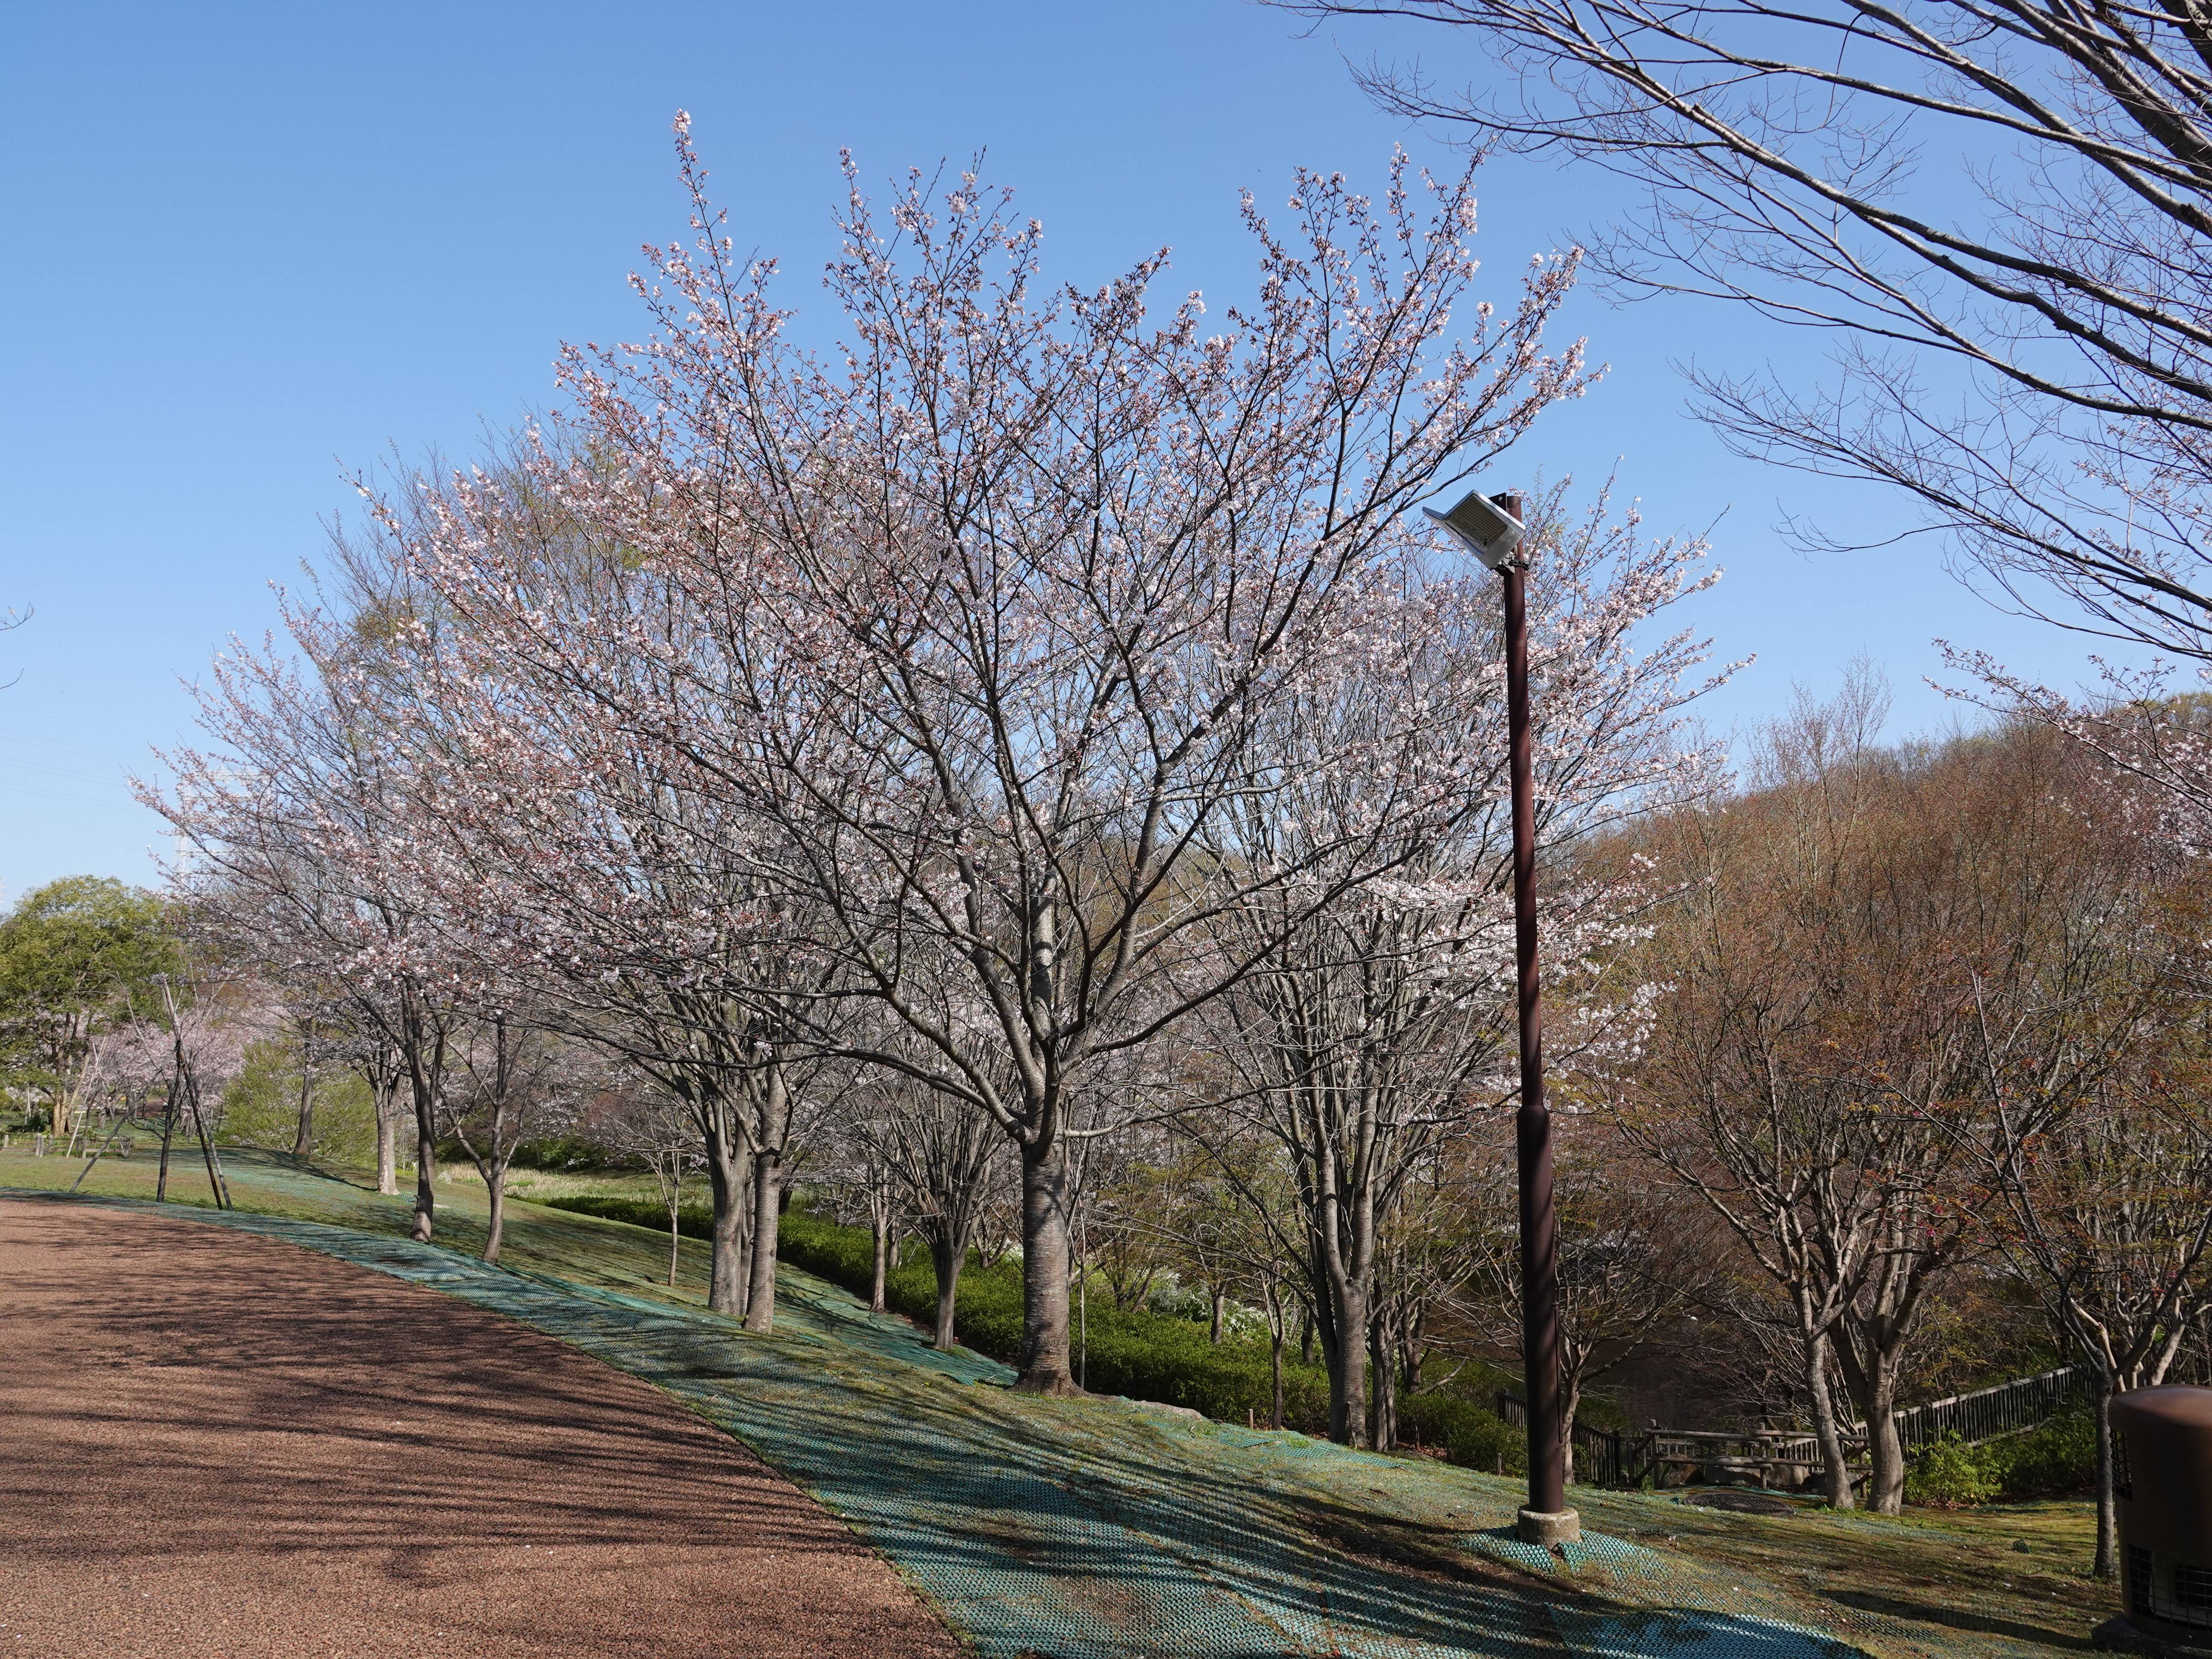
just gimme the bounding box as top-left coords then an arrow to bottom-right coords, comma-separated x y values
0,0 -> 2114,900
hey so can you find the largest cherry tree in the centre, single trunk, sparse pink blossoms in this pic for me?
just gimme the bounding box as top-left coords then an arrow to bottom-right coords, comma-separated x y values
506,139 -> 1588,1391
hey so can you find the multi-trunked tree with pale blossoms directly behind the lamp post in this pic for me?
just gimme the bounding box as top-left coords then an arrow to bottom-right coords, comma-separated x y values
1186,489 -> 1703,1444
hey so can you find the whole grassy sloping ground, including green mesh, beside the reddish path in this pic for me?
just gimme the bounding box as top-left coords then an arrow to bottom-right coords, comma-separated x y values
0,1144 -> 2115,1659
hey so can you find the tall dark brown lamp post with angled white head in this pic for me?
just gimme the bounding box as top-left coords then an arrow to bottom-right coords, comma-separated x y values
1423,493 -> 1582,1546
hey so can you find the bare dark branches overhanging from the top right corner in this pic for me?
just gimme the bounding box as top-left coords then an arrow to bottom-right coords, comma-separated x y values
1277,0 -> 2212,659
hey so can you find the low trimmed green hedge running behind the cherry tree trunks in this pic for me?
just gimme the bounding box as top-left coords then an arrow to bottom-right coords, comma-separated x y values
546,1196 -> 1526,1473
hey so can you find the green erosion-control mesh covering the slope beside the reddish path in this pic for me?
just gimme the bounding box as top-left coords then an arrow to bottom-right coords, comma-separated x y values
20,1195 -> 1946,1659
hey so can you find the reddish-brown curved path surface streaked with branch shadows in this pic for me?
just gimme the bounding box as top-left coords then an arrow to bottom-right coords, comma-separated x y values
0,1201 -> 955,1659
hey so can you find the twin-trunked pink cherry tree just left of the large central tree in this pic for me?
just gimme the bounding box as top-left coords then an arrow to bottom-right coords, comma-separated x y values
321,473 -> 836,1332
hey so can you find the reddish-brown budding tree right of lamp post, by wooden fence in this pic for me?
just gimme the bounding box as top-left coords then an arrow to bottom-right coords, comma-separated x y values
1628,677 -> 2159,1513
